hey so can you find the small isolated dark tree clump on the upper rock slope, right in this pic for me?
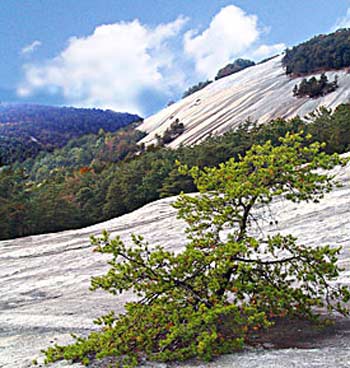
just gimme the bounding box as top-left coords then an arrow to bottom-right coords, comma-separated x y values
293,73 -> 338,98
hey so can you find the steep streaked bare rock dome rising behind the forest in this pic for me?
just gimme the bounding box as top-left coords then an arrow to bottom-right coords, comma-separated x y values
138,56 -> 350,148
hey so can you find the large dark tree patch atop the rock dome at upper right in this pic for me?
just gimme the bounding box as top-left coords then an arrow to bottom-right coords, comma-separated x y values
282,29 -> 350,76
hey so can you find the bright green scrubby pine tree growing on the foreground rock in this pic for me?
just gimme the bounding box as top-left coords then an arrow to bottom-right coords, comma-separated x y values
46,134 -> 350,366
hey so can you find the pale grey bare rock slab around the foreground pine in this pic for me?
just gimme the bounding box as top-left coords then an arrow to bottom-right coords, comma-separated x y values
0,157 -> 350,368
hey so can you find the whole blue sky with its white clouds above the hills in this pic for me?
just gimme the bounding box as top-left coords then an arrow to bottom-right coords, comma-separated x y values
0,0 -> 350,116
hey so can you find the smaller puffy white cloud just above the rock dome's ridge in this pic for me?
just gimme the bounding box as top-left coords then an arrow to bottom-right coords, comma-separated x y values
184,5 -> 285,78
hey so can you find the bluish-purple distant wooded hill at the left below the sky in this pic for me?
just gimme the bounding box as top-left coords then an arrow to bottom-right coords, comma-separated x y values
0,104 -> 141,166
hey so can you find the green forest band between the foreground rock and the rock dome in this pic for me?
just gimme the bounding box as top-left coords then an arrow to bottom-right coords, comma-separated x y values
0,104 -> 350,239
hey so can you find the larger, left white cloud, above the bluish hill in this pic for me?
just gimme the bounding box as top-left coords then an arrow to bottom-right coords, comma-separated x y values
17,17 -> 186,114
